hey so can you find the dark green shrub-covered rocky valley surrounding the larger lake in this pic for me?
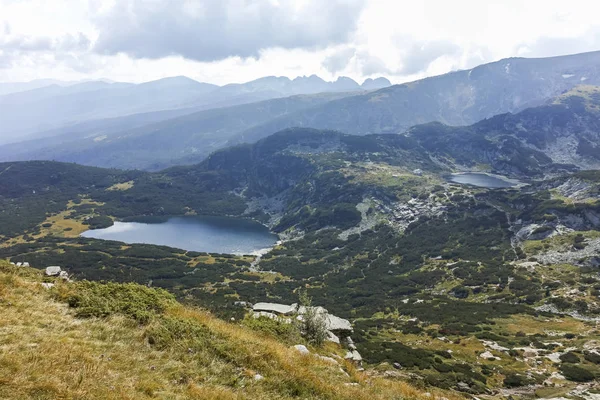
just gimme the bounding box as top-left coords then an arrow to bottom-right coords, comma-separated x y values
0,113 -> 600,397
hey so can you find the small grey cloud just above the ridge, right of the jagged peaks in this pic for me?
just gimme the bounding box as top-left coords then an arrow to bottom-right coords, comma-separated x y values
398,39 -> 461,75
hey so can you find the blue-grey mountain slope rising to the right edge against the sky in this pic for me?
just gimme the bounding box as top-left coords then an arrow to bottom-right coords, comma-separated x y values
242,52 -> 600,140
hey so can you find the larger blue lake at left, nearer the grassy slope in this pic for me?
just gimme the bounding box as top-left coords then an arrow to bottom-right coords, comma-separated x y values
81,216 -> 278,254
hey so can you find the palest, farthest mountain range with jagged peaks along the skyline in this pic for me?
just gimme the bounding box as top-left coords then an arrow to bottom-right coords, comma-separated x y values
0,75 -> 390,143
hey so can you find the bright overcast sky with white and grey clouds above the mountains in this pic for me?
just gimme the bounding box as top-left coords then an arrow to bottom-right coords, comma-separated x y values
0,0 -> 600,84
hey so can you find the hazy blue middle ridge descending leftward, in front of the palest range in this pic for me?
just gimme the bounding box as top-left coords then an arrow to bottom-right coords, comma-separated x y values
0,93 -> 360,170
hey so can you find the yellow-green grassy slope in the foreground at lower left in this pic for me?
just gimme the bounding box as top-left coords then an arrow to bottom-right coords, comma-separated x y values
0,261 -> 455,399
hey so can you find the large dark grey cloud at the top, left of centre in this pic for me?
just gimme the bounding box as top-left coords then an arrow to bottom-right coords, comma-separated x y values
94,0 -> 366,61
